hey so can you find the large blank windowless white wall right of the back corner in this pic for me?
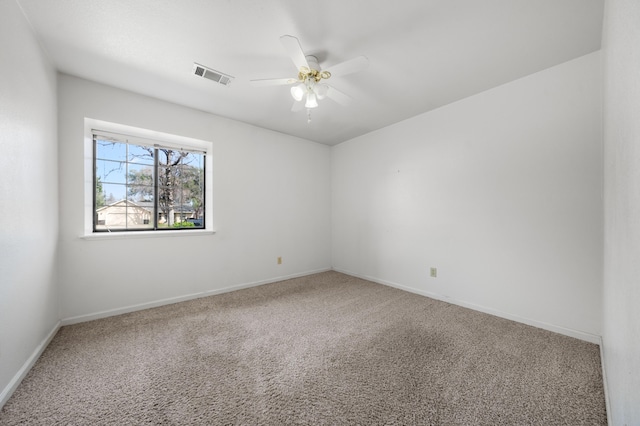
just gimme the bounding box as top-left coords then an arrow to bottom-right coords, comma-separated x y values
332,52 -> 602,342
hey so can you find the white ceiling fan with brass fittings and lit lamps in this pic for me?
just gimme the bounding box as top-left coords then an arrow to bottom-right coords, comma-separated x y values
251,35 -> 369,121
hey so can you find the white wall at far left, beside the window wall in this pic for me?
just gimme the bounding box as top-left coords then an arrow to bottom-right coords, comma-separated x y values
0,1 -> 58,406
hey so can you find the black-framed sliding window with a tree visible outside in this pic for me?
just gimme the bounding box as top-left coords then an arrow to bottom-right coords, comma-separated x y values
91,129 -> 207,232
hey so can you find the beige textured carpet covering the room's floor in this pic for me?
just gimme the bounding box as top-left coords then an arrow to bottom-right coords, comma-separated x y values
0,272 -> 606,425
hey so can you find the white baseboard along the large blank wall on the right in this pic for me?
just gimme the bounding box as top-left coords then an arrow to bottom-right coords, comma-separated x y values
333,268 -> 601,345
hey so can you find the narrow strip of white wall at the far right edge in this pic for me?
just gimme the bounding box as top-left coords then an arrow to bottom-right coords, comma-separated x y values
603,0 -> 640,425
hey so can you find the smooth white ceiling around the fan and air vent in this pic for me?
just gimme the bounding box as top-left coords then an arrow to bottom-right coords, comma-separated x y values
16,0 -> 604,145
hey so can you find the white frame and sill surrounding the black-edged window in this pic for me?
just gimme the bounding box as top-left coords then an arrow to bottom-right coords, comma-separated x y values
81,118 -> 215,239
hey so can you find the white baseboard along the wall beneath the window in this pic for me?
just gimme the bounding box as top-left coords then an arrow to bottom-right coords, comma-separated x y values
61,268 -> 331,326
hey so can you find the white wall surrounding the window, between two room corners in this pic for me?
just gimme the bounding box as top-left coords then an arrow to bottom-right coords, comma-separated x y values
58,75 -> 331,321
